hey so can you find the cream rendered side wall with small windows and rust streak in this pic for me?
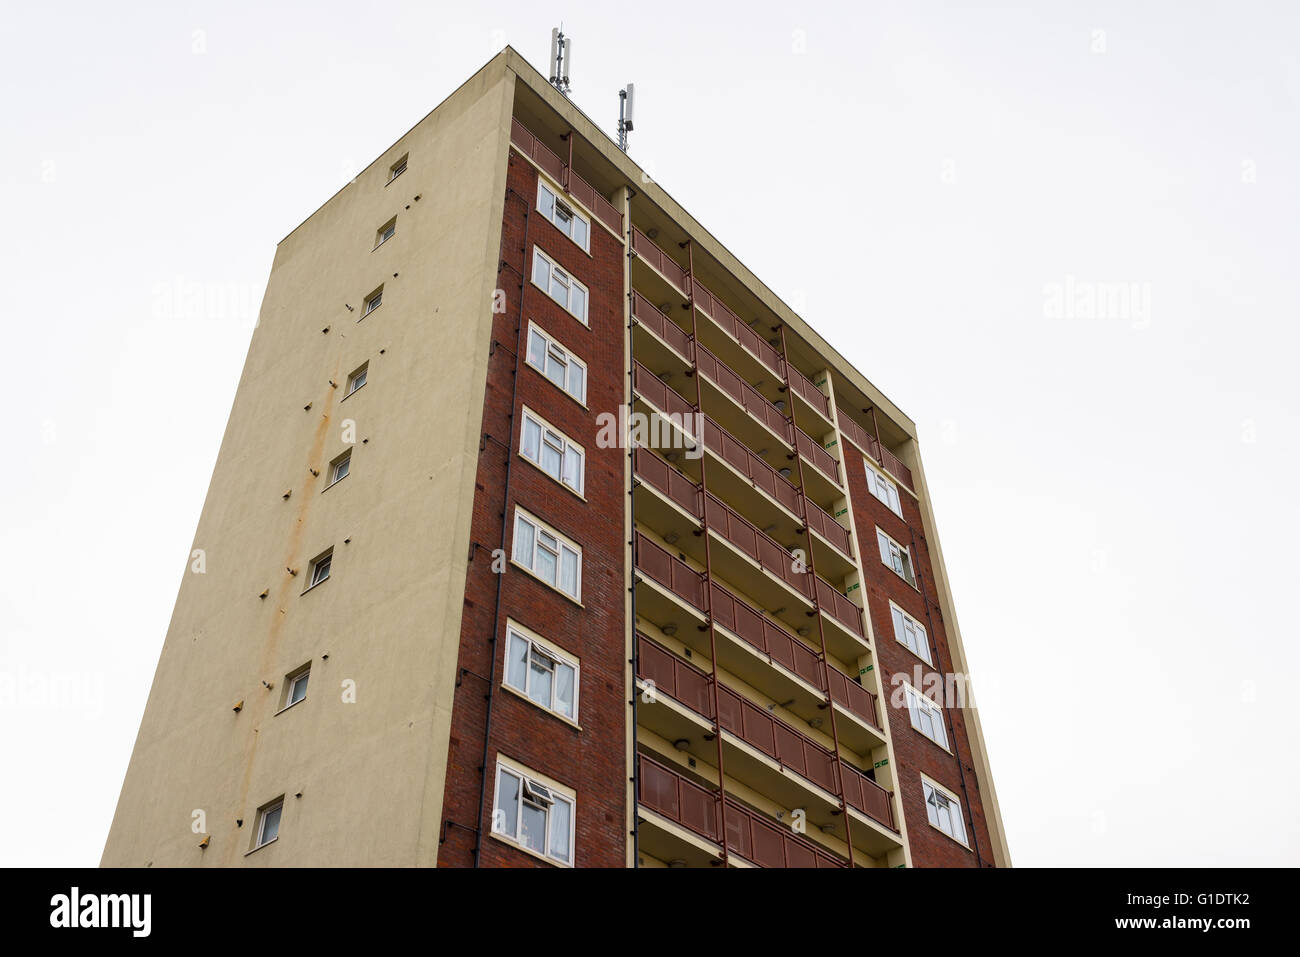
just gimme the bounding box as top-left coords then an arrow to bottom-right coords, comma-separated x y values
103,53 -> 515,866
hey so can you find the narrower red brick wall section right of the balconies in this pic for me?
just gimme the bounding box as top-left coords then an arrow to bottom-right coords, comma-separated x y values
844,443 -> 993,867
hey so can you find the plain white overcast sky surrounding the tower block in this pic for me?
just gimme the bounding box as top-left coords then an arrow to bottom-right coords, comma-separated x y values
0,0 -> 1300,865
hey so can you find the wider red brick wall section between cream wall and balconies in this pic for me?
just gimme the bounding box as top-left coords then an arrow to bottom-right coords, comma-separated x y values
432,151 -> 628,867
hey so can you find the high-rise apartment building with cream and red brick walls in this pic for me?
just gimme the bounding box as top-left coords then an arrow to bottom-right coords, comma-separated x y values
103,48 -> 1009,867
